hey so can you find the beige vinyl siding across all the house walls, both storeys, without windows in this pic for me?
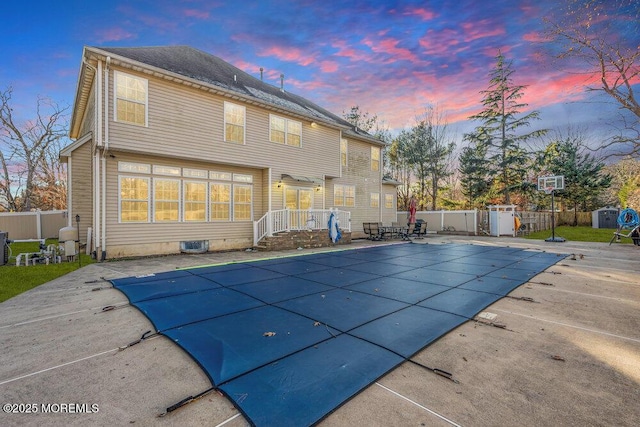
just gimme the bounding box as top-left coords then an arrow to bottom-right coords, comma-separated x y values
73,59 -> 395,254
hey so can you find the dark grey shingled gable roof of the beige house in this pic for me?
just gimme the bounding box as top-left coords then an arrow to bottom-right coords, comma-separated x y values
72,46 -> 384,144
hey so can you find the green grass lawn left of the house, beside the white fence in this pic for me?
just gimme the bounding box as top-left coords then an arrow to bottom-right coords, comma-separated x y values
0,239 -> 94,302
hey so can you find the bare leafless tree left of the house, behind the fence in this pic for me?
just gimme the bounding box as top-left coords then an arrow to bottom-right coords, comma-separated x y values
0,87 -> 68,211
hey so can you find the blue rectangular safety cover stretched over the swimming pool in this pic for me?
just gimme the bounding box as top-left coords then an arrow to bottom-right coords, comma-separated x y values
112,244 -> 560,426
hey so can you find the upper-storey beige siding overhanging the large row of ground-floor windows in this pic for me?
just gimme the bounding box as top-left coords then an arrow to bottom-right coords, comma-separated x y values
109,67 -> 340,181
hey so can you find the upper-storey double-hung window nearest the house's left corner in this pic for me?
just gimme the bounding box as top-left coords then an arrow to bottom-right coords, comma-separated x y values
114,71 -> 148,126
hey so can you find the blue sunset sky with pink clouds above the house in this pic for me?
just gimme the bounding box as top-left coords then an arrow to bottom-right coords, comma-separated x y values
0,0 -> 636,145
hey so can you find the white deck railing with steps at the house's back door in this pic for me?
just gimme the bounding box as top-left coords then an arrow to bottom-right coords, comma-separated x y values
253,209 -> 351,246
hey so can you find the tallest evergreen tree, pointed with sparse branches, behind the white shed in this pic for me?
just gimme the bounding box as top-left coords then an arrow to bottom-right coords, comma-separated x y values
464,52 -> 546,204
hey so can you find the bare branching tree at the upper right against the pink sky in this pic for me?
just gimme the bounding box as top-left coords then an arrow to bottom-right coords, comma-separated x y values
545,0 -> 640,156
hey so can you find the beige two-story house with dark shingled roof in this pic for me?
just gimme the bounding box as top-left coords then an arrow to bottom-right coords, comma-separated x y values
61,46 -> 396,259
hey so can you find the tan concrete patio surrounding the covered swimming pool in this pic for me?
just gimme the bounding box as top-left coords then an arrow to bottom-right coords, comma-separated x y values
0,236 -> 640,426
